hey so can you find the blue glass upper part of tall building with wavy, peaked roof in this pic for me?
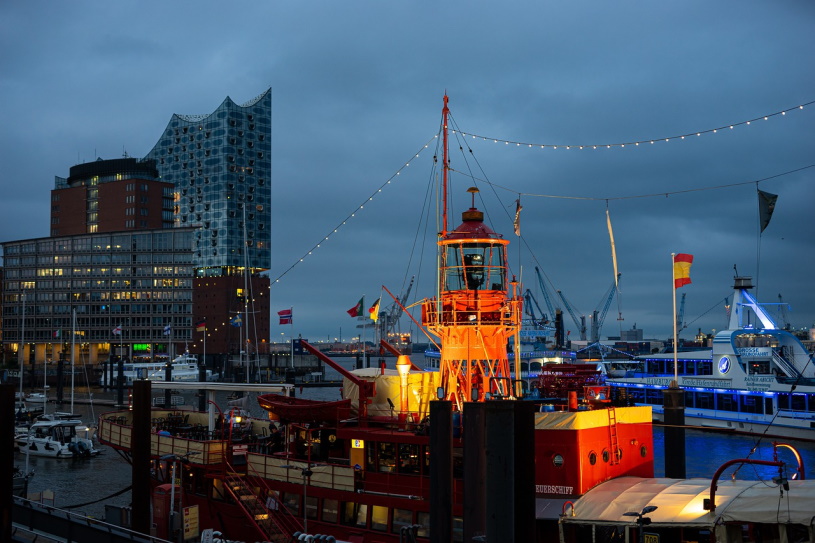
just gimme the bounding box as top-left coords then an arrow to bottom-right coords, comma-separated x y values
145,89 -> 272,277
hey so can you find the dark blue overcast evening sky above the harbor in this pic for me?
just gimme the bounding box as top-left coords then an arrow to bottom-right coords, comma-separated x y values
0,0 -> 815,341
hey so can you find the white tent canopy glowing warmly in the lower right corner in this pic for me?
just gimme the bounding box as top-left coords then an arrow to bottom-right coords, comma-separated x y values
561,477 -> 815,528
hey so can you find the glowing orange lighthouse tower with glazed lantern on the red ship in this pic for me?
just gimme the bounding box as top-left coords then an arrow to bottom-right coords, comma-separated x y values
422,188 -> 523,410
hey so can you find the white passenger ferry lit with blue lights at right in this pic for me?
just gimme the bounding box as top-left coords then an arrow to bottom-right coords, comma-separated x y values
606,277 -> 815,441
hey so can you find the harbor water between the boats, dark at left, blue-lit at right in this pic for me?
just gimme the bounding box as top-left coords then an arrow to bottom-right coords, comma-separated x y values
15,378 -> 815,519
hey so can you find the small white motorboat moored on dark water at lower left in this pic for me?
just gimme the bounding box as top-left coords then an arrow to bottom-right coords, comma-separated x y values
14,419 -> 100,458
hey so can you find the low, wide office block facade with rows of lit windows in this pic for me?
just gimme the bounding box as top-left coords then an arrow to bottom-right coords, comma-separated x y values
2,228 -> 196,363
